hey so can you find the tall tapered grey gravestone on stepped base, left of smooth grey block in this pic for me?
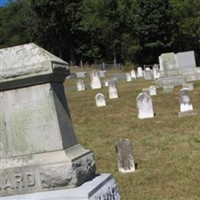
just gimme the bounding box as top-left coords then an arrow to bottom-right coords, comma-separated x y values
156,53 -> 185,87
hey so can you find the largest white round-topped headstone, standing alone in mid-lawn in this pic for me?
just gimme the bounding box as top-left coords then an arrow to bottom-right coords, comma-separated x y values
136,92 -> 154,119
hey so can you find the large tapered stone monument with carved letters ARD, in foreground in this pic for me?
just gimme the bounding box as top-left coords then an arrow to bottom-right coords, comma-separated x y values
0,43 -> 118,200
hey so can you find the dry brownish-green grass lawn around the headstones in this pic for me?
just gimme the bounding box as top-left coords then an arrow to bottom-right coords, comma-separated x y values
65,68 -> 200,200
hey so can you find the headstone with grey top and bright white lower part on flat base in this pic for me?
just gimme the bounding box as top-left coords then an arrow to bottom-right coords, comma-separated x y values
179,89 -> 196,117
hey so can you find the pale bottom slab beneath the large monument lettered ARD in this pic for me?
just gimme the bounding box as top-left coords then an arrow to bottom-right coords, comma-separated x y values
1,174 -> 120,200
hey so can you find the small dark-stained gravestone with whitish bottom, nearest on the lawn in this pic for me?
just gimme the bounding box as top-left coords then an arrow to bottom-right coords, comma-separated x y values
115,139 -> 135,173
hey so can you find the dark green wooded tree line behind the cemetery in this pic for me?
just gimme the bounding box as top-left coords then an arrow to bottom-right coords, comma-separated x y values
0,0 -> 200,65
